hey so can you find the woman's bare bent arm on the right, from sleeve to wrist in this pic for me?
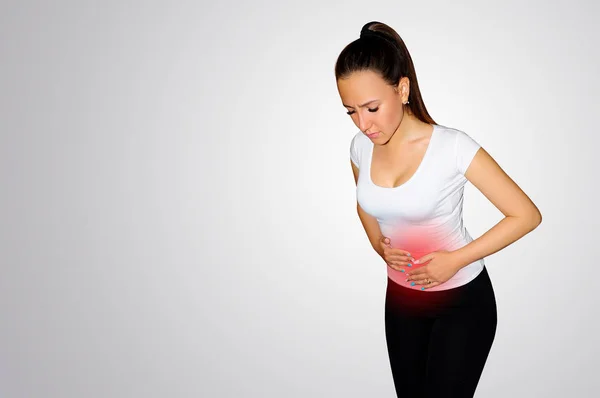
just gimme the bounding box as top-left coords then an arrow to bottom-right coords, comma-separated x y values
452,148 -> 542,269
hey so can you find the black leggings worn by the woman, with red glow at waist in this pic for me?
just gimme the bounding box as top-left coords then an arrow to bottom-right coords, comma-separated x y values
385,267 -> 497,398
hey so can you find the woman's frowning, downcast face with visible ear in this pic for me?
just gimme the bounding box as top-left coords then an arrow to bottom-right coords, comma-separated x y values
337,71 -> 408,143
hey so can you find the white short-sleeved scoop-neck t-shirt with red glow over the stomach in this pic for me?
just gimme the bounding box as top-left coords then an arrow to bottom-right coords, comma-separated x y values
350,125 -> 484,291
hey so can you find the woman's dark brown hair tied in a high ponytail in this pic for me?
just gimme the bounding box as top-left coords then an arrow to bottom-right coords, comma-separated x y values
335,21 -> 437,124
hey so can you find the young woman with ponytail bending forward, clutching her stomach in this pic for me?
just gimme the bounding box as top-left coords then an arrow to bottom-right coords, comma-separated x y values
335,22 -> 542,398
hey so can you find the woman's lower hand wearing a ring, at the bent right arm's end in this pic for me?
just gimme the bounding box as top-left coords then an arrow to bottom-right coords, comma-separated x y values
406,250 -> 461,289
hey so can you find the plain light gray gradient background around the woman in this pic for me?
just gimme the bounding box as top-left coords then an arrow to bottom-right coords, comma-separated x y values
0,1 -> 600,398
